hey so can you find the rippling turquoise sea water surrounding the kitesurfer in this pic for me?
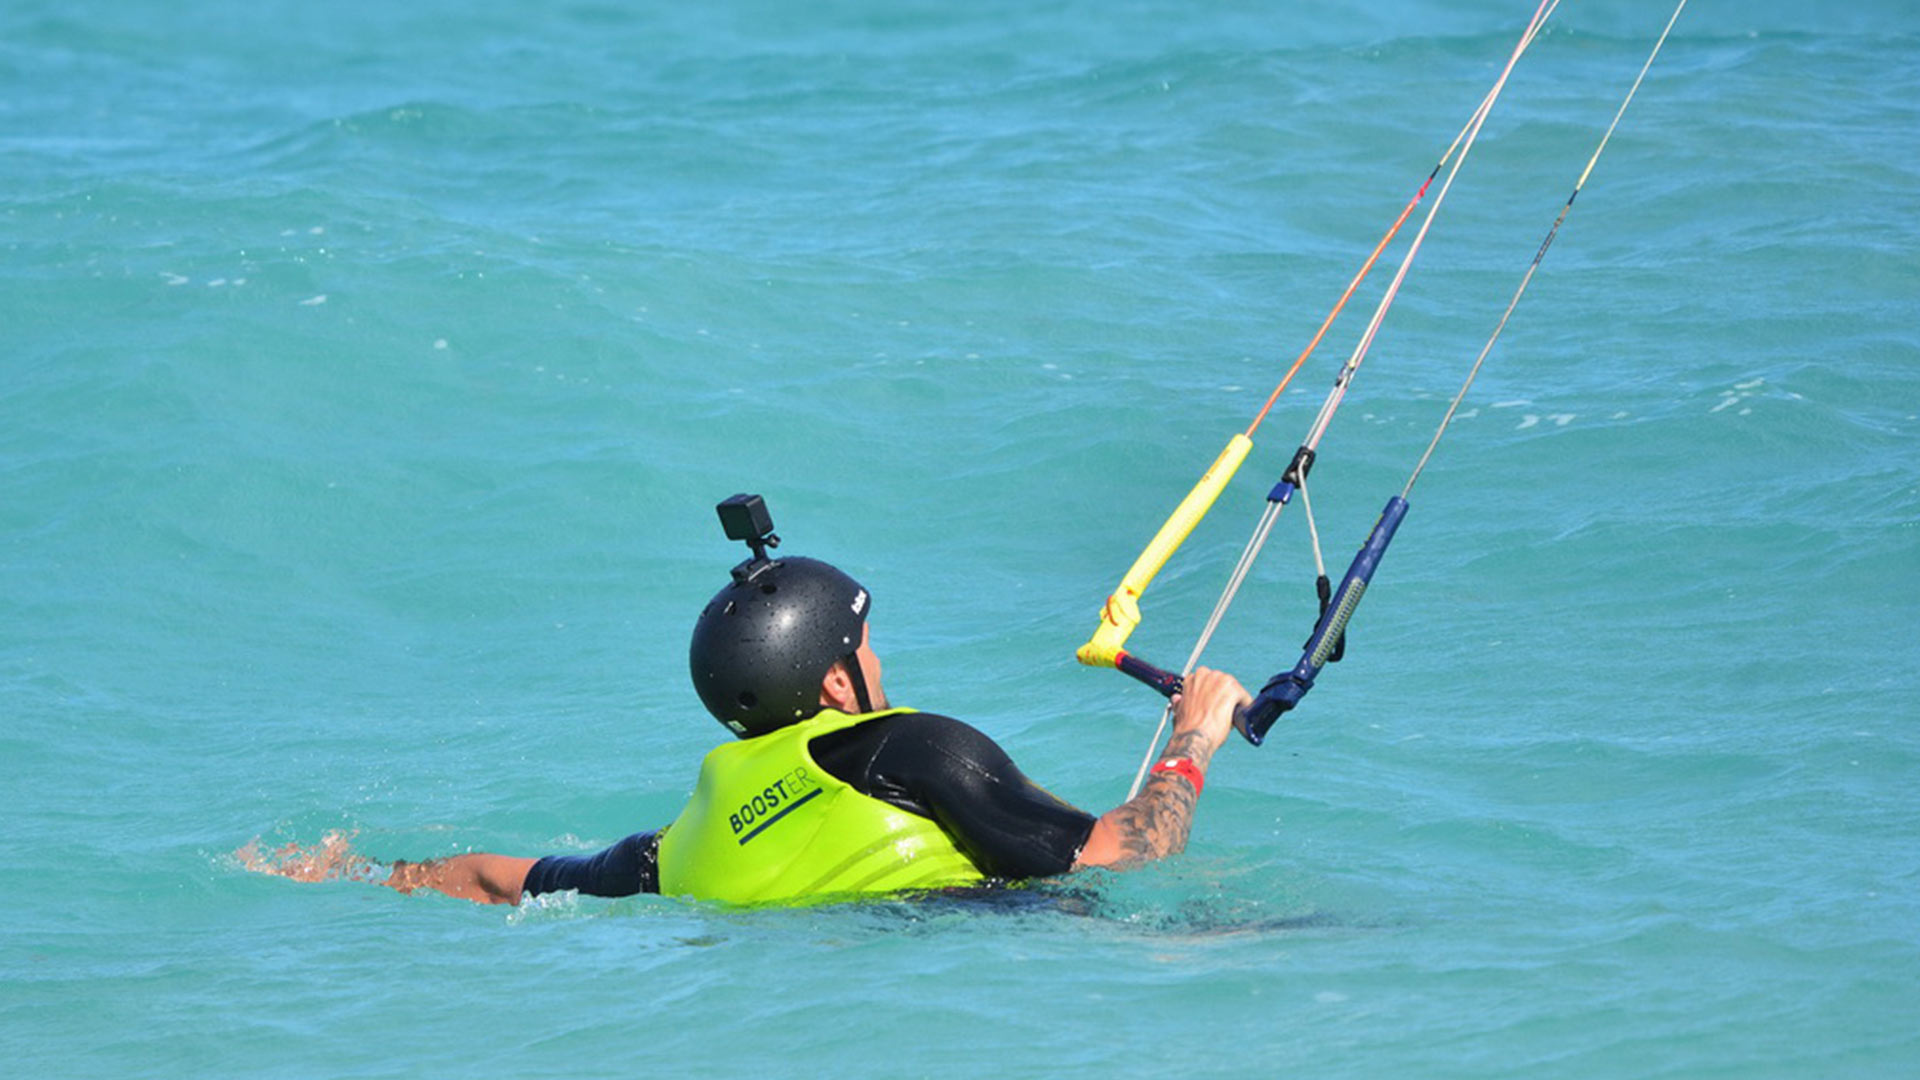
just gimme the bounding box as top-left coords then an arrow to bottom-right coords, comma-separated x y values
0,0 -> 1920,1078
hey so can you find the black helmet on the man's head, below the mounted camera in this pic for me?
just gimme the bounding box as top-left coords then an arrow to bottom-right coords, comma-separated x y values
687,534 -> 868,738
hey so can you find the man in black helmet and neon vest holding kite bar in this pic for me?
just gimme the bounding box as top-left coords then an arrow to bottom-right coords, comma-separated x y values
242,496 -> 1250,903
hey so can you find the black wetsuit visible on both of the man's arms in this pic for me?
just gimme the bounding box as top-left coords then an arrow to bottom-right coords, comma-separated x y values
524,713 -> 1094,896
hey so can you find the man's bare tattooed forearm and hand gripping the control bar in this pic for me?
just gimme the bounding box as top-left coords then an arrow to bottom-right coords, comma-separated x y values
1073,667 -> 1252,871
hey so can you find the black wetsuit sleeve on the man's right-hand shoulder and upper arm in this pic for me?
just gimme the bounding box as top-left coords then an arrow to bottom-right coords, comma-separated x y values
814,713 -> 1094,878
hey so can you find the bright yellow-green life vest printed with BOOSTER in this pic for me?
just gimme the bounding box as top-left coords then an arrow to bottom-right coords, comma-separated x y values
660,709 -> 985,903
